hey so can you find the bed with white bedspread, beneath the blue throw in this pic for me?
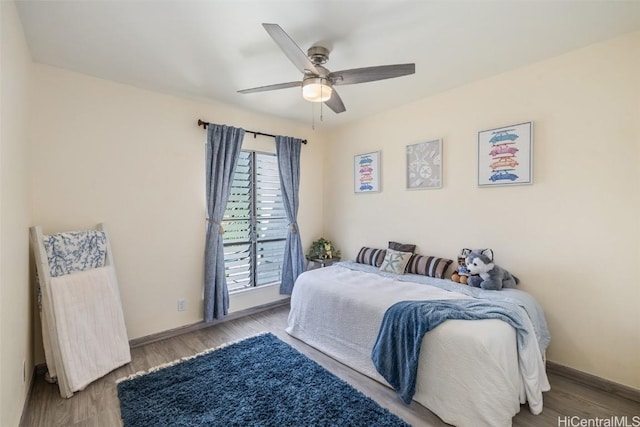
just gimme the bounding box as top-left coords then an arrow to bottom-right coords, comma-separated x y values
287,261 -> 550,427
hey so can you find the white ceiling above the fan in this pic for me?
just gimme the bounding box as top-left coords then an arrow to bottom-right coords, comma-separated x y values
16,0 -> 640,127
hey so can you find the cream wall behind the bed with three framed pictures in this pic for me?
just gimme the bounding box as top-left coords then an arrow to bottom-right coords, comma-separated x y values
324,32 -> 640,388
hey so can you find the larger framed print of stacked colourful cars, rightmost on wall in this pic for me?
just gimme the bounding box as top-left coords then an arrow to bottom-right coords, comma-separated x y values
478,122 -> 533,187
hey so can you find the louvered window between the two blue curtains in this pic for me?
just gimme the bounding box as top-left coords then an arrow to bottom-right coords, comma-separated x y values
222,151 -> 289,292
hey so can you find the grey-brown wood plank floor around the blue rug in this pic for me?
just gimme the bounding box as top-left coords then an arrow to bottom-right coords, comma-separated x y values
22,306 -> 640,427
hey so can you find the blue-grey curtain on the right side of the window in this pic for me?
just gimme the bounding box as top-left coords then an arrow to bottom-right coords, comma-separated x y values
276,136 -> 304,295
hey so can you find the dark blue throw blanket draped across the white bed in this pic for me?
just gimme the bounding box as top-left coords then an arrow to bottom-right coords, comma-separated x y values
371,299 -> 527,404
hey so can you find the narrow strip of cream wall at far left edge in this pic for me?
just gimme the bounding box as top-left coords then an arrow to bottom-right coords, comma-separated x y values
0,1 -> 33,426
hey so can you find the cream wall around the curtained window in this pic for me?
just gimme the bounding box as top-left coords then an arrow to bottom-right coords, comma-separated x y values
30,65 -> 324,354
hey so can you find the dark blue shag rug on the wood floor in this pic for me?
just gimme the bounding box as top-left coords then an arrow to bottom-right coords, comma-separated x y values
118,333 -> 409,427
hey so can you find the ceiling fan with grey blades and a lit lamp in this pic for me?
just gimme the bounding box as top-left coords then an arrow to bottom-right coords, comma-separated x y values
238,24 -> 416,113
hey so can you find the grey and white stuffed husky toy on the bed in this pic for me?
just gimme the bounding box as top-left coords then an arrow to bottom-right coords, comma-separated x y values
467,249 -> 520,291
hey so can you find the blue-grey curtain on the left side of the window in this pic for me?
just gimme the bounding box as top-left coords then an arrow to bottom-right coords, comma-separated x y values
204,123 -> 244,322
